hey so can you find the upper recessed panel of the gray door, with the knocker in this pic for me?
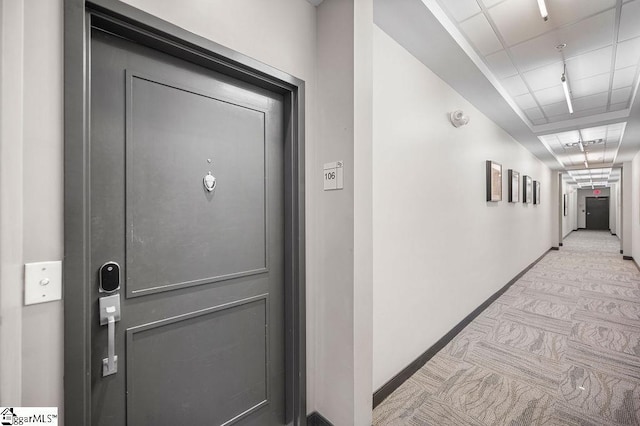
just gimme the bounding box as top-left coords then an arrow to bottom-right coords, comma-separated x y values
126,73 -> 267,295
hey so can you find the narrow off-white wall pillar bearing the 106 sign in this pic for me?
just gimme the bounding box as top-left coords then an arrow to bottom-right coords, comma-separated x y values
310,0 -> 373,425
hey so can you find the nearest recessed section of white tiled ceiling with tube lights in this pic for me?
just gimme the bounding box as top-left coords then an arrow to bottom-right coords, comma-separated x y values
438,0 -> 640,126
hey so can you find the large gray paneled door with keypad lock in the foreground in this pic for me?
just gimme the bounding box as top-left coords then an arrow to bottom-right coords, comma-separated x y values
87,30 -> 285,426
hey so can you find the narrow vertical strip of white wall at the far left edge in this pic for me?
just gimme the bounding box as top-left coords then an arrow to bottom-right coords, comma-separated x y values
0,0 -> 24,406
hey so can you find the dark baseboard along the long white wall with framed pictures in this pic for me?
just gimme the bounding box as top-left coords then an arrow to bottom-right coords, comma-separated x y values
373,248 -> 557,408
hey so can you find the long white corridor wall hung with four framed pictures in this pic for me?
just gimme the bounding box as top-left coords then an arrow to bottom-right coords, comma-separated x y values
373,27 -> 557,389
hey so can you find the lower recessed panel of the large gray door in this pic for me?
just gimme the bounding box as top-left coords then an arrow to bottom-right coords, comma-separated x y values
127,296 -> 269,425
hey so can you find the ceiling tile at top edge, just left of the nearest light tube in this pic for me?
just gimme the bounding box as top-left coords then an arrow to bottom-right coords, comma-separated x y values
489,0 -> 553,46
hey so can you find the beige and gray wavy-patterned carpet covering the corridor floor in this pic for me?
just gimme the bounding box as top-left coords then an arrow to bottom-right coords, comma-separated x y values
373,231 -> 640,426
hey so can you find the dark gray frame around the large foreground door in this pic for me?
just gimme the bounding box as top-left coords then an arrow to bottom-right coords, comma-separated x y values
63,0 -> 306,425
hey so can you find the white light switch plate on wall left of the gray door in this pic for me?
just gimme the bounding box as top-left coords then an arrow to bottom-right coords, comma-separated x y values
24,261 -> 62,305
